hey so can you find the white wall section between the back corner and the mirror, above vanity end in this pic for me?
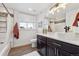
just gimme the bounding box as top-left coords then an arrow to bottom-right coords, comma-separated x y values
37,10 -> 48,33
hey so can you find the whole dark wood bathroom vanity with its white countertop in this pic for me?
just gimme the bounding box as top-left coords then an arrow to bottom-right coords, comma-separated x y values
37,34 -> 79,56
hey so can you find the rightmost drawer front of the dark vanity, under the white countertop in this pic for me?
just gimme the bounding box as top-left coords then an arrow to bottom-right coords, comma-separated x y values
59,42 -> 79,55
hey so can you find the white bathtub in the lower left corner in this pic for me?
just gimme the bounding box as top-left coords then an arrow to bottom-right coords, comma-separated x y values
0,43 -> 10,56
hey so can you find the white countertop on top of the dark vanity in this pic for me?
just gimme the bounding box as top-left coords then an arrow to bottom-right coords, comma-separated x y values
37,33 -> 79,46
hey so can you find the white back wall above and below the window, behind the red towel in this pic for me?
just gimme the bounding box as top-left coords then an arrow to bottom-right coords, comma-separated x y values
14,11 -> 36,47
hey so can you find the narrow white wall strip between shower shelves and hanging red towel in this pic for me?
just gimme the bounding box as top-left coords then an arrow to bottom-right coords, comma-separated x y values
6,15 -> 13,42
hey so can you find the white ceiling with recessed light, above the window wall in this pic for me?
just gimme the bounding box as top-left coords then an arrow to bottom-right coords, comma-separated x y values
1,3 -> 51,15
